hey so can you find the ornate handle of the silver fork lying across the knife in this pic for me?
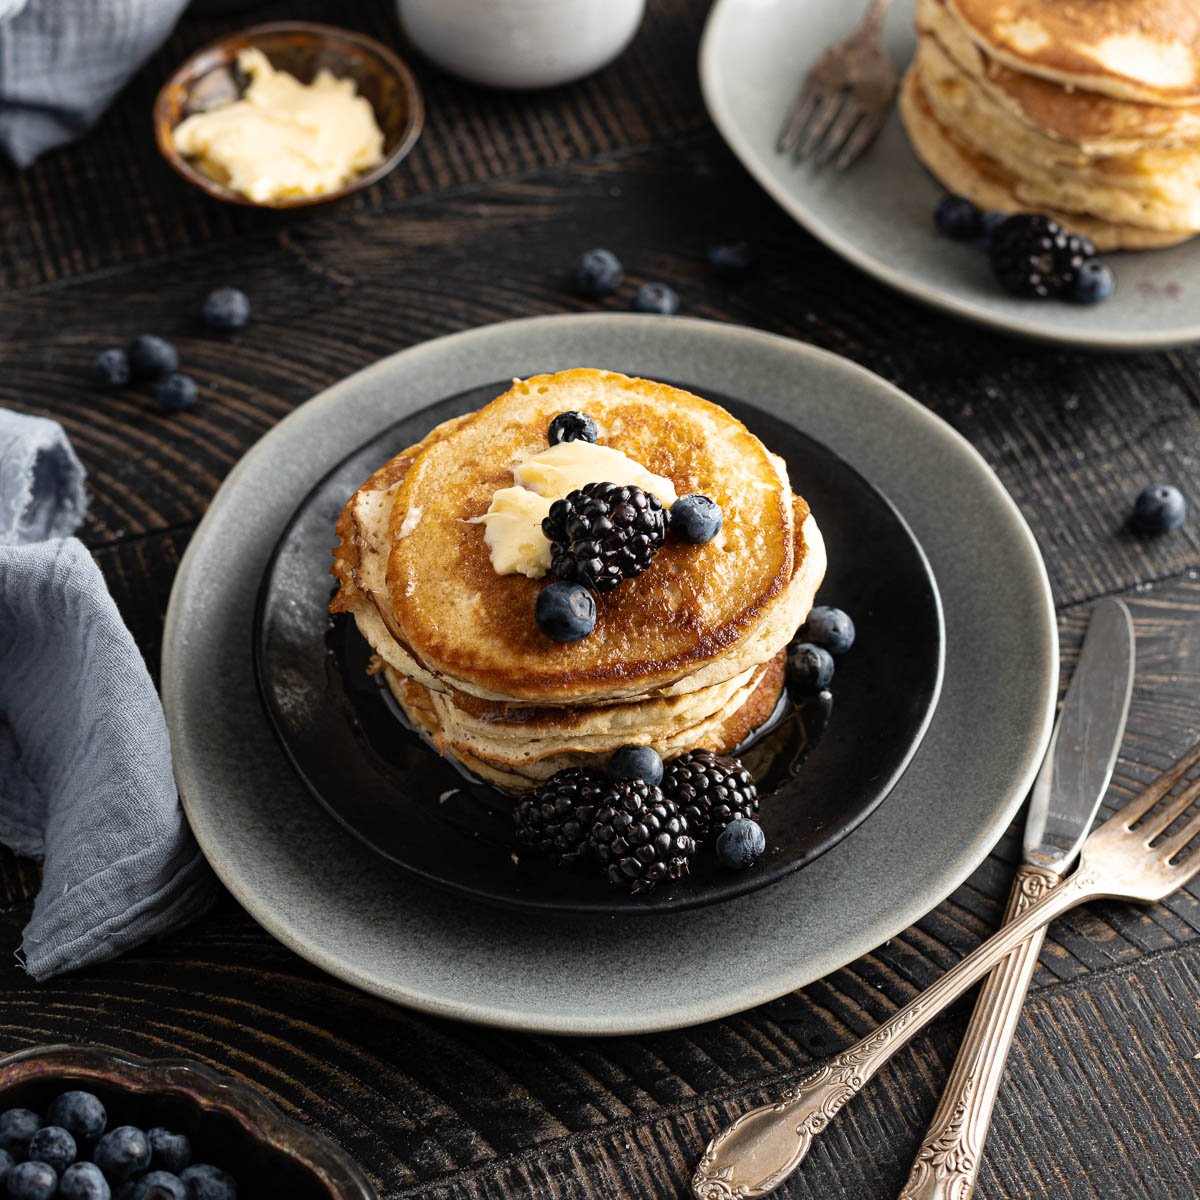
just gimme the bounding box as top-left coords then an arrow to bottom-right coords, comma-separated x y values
691,866 -> 1109,1200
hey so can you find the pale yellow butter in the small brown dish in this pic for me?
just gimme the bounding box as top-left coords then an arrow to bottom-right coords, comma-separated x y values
174,48 -> 383,200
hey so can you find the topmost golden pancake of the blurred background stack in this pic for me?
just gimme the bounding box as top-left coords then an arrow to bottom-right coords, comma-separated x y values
948,0 -> 1200,104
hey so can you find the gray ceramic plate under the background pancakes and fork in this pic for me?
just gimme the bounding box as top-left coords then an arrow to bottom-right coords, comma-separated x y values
700,0 -> 1200,349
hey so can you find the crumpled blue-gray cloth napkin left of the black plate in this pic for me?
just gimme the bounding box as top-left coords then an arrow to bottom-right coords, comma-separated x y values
0,409 -> 216,979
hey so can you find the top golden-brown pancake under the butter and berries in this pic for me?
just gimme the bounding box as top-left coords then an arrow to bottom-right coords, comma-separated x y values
336,370 -> 823,703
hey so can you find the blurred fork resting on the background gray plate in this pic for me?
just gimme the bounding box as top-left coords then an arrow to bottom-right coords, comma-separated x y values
775,0 -> 896,170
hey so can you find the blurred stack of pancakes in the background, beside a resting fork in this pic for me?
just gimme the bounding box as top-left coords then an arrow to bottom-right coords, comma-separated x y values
900,0 -> 1200,250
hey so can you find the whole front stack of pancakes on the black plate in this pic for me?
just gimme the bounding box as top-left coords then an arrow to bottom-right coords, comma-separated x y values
330,370 -> 826,790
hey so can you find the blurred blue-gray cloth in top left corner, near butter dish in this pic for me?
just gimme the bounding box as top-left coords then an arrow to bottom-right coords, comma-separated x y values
0,0 -> 187,167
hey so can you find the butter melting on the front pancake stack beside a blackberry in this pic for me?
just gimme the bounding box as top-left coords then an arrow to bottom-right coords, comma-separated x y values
470,442 -> 678,580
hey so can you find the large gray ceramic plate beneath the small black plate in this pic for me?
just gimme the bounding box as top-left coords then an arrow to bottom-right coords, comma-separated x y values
162,314 -> 1057,1033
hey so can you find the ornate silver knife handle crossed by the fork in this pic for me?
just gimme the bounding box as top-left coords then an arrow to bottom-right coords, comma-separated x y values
899,864 -> 1062,1200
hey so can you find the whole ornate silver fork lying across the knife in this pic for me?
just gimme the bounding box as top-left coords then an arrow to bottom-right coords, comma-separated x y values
691,743 -> 1200,1200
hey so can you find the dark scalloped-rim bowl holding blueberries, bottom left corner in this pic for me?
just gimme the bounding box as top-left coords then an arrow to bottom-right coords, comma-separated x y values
0,1045 -> 378,1200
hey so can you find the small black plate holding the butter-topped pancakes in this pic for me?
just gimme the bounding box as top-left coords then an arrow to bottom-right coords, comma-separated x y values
253,382 -> 943,913
